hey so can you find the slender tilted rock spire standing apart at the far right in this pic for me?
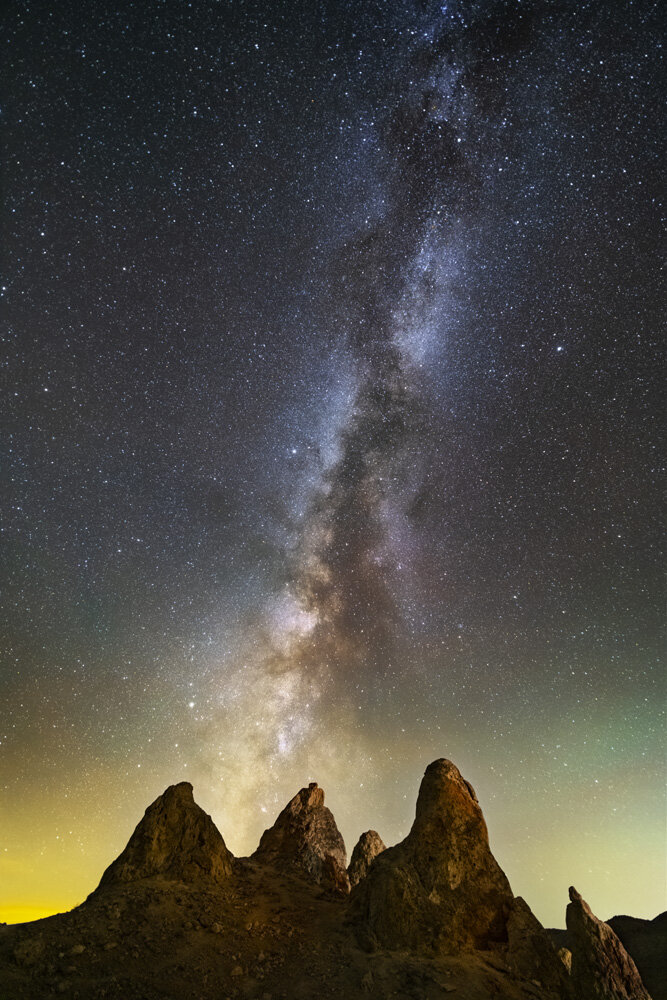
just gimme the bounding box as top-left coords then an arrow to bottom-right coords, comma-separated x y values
565,886 -> 650,1000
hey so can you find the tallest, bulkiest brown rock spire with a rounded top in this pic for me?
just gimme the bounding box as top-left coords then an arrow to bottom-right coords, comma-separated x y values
350,760 -> 514,953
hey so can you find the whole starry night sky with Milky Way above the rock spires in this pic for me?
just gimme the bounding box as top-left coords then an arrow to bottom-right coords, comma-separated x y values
0,0 -> 666,926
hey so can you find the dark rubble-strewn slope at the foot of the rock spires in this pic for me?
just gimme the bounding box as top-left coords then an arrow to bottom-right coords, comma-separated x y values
0,861 -> 576,1000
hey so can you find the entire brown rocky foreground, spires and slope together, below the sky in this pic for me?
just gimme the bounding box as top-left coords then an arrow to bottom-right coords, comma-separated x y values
0,761 -> 648,1000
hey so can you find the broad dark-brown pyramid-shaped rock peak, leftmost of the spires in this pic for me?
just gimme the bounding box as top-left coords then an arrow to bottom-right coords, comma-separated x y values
98,781 -> 232,891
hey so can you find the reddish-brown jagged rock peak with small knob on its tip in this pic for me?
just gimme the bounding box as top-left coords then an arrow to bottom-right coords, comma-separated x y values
252,782 -> 349,892
